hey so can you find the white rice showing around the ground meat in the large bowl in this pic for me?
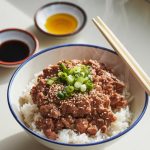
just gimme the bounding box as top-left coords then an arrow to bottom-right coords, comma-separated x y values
20,74 -> 132,144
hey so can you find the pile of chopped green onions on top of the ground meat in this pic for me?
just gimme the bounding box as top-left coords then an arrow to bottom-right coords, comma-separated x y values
55,63 -> 93,99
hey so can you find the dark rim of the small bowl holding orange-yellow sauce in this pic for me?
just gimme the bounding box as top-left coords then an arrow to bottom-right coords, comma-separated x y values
34,2 -> 87,37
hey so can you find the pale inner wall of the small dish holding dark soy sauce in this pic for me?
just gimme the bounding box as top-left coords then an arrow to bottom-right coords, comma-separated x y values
0,30 -> 36,55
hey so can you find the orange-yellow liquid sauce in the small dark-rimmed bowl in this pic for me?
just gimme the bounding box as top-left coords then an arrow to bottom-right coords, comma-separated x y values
45,13 -> 78,35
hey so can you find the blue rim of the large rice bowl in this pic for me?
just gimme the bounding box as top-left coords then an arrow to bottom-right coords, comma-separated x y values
7,44 -> 148,147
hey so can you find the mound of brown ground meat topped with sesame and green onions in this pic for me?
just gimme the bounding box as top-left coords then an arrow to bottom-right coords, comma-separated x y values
30,60 -> 127,140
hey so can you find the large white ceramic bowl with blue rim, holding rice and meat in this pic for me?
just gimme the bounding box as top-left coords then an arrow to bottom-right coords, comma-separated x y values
7,44 -> 148,150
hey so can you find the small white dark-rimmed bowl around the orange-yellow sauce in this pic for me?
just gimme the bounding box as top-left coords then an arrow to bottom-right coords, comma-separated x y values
34,2 -> 87,37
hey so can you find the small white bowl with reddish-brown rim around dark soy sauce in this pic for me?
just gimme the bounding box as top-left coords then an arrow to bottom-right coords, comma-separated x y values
0,28 -> 39,68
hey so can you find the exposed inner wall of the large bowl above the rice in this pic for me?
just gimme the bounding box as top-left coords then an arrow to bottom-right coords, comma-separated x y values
8,45 -> 146,145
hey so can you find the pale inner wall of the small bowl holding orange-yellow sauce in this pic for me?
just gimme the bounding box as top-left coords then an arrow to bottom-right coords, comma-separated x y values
35,3 -> 86,32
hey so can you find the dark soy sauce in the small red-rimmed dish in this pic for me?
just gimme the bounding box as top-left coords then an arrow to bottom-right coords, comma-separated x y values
0,40 -> 30,62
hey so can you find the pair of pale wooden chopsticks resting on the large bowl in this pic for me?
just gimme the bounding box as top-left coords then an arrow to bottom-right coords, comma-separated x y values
93,16 -> 150,95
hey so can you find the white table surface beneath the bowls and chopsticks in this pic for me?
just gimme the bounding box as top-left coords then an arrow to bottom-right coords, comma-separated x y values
0,0 -> 150,150
